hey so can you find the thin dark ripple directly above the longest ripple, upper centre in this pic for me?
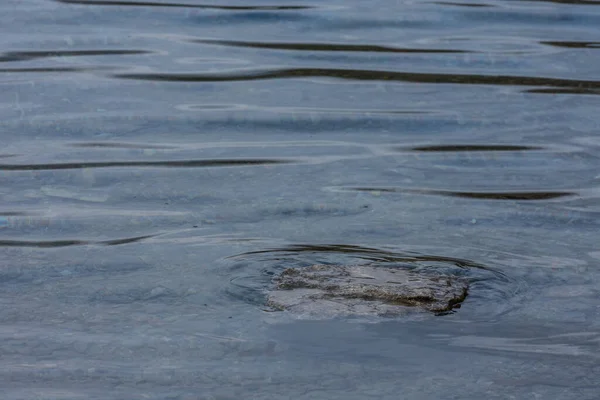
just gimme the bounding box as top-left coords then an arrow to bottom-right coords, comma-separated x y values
195,39 -> 474,53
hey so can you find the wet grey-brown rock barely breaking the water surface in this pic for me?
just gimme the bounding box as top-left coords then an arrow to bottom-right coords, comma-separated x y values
267,264 -> 469,317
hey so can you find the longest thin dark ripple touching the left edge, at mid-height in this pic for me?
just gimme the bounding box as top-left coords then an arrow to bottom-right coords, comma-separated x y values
0,159 -> 292,171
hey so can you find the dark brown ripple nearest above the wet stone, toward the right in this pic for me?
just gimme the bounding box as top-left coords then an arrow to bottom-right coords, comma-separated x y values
351,187 -> 577,200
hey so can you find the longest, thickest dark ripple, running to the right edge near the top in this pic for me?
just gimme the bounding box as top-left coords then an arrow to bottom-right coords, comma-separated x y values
113,68 -> 600,89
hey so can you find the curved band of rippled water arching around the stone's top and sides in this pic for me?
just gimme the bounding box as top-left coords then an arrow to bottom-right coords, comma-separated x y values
224,244 -> 521,317
